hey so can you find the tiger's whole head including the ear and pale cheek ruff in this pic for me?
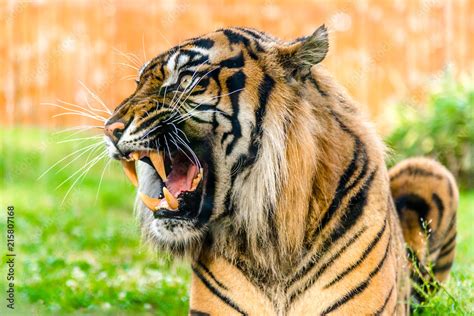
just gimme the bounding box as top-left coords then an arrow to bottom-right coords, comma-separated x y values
105,26 -> 328,260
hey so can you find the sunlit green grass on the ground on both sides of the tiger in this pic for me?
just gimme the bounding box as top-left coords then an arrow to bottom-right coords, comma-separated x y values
0,128 -> 474,315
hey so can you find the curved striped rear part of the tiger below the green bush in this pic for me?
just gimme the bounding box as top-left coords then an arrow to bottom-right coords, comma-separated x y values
389,158 -> 459,302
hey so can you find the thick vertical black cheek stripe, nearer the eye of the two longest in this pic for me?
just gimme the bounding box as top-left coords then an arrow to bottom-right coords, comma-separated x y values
221,70 -> 246,155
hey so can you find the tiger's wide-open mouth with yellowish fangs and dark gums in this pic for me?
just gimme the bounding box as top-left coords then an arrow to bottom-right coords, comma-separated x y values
121,150 -> 204,217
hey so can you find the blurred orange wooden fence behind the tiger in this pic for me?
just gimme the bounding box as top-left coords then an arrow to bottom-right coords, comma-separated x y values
0,0 -> 474,131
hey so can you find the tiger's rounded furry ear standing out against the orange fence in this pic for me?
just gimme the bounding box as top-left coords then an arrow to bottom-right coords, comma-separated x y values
278,24 -> 329,79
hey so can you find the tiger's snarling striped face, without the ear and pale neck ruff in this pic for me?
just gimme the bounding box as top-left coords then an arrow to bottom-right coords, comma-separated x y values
105,28 -> 325,252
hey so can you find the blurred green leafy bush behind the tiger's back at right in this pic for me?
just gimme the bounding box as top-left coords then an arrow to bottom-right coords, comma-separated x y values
386,75 -> 474,188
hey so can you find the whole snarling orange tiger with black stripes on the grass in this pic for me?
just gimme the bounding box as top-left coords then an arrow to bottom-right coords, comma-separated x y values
104,25 -> 458,315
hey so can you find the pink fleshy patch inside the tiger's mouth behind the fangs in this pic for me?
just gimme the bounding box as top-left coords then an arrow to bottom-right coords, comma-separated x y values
165,157 -> 199,197
